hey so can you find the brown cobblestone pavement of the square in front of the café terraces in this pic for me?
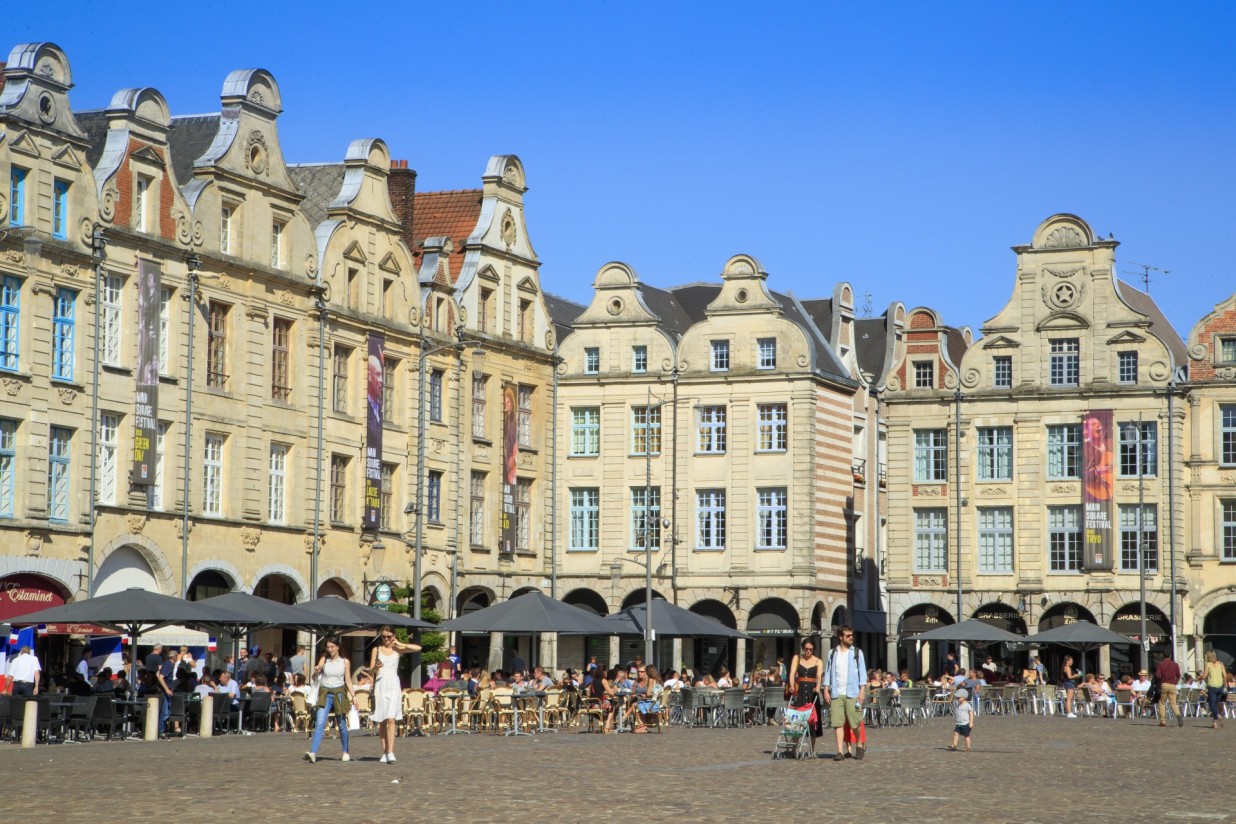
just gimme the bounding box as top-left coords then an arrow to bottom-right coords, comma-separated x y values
0,717 -> 1236,824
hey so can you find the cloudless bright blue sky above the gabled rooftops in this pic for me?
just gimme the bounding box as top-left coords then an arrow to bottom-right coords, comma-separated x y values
12,0 -> 1236,335
